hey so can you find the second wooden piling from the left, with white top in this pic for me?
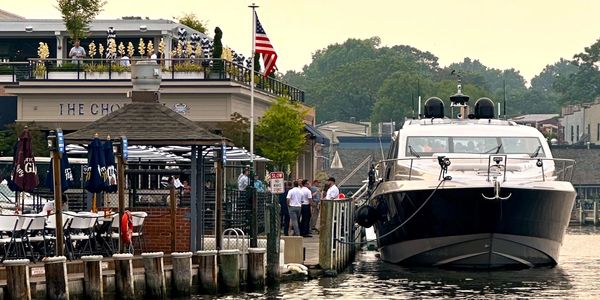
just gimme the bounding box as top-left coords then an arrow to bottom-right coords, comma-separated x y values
42,256 -> 69,300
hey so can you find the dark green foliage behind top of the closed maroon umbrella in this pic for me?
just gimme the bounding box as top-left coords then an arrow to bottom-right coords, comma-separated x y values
0,123 -> 50,156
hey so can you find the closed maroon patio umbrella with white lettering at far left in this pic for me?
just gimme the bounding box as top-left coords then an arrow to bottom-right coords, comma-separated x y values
11,128 -> 39,213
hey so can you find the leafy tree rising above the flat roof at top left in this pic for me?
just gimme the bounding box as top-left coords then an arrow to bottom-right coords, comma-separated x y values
56,0 -> 106,41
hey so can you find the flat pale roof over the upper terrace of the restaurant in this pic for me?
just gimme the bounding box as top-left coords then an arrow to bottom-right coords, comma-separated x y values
0,17 -> 206,38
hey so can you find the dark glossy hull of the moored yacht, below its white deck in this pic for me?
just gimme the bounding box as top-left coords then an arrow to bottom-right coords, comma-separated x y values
374,184 -> 576,268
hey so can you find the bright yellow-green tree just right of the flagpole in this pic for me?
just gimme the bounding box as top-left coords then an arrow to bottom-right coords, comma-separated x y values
256,98 -> 306,170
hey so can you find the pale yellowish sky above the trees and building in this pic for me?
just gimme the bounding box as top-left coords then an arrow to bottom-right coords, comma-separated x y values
0,0 -> 600,80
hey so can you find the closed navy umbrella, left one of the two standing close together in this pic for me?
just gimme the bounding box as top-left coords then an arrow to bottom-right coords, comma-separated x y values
85,138 -> 106,193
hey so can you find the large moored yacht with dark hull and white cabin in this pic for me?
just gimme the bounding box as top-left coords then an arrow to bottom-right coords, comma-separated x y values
359,82 -> 576,268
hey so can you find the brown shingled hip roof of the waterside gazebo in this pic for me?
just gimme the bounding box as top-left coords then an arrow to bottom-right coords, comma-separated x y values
65,102 -> 229,146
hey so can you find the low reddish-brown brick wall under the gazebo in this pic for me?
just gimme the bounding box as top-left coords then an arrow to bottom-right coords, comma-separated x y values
132,207 -> 191,253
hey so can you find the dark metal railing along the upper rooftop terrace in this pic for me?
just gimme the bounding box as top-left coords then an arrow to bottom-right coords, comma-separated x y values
0,58 -> 304,102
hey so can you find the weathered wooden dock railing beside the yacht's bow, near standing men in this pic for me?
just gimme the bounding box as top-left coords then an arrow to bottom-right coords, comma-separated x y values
319,198 -> 361,272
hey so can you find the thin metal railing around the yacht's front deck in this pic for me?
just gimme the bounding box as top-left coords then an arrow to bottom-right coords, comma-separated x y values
378,154 -> 575,182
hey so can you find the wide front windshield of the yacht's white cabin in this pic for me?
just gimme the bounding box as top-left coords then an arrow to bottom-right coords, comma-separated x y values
405,136 -> 545,157
